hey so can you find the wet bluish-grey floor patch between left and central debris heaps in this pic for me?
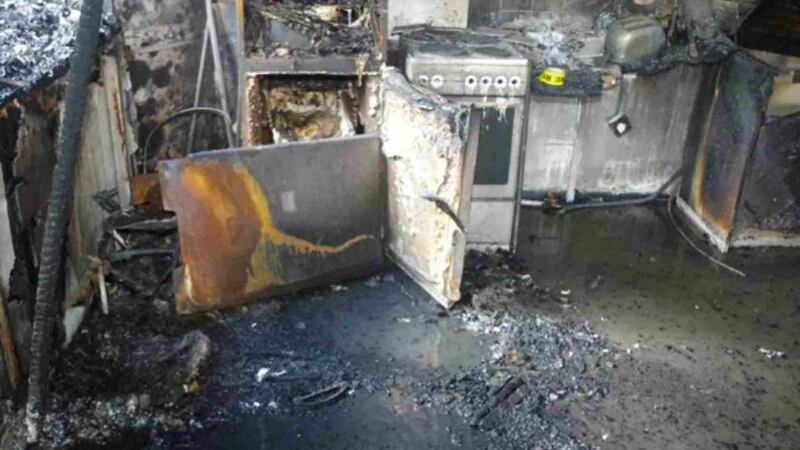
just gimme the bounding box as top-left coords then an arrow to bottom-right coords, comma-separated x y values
157,271 -> 490,450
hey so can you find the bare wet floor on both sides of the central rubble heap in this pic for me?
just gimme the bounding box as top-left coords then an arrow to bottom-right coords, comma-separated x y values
134,208 -> 800,449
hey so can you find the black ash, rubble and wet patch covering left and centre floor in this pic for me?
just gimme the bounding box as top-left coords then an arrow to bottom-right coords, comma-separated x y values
4,244 -> 615,449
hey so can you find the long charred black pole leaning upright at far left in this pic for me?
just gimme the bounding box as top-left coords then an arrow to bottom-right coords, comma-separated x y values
25,0 -> 103,442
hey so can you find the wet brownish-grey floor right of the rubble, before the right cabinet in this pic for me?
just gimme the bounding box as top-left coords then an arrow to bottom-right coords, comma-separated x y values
518,208 -> 800,449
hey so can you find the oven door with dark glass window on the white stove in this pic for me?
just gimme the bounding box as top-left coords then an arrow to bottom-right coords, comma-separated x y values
465,98 -> 525,250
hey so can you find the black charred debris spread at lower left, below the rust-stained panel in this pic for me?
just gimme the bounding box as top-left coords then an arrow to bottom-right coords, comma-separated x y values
21,288 -> 364,449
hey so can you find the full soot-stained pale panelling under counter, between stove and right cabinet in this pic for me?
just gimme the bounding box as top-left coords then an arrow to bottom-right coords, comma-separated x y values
524,66 -> 716,195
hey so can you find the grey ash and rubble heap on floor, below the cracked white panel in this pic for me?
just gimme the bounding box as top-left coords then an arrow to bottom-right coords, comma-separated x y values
417,310 -> 614,450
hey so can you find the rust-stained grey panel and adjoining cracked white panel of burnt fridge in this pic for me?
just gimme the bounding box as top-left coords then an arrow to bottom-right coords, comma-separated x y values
159,69 -> 477,313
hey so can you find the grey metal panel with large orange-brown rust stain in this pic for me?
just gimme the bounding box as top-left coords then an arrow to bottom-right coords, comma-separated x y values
159,136 -> 384,313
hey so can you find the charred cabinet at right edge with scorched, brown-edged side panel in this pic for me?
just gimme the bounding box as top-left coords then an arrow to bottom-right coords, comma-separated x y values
678,53 -> 800,252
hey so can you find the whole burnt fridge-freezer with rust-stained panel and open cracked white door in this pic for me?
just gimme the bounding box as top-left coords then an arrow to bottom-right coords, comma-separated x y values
159,0 -> 484,313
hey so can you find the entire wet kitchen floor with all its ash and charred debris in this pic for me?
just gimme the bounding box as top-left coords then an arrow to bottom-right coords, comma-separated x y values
4,207 -> 800,449
